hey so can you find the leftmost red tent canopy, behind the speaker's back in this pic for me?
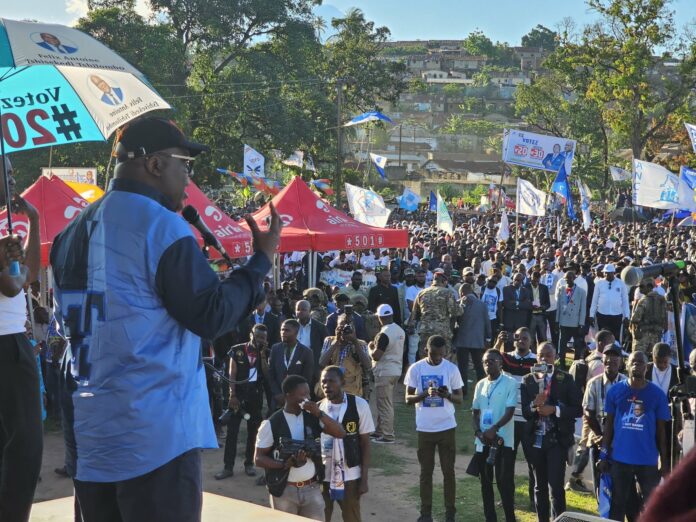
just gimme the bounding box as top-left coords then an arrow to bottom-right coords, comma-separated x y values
0,176 -> 89,266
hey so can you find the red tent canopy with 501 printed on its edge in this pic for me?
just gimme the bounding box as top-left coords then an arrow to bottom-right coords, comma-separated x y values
240,177 -> 408,252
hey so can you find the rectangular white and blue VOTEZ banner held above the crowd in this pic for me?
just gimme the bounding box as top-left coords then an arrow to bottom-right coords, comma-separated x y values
503,129 -> 576,176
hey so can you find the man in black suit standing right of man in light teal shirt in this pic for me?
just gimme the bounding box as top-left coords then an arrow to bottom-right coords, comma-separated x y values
520,342 -> 582,522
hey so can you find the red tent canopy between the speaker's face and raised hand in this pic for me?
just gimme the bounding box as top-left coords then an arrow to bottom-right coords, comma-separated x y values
186,182 -> 253,258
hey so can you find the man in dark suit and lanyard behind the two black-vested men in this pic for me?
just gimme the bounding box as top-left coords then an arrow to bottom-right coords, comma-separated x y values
268,319 -> 314,410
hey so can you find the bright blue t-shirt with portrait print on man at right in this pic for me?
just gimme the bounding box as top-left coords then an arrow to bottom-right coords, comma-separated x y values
604,381 -> 671,466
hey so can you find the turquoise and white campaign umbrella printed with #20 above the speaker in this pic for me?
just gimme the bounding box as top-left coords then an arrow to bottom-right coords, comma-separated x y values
0,18 -> 171,238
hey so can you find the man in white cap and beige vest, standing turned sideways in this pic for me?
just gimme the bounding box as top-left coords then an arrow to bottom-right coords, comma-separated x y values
368,304 -> 406,444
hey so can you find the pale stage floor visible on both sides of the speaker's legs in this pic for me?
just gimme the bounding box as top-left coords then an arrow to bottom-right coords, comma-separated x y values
29,493 -> 307,522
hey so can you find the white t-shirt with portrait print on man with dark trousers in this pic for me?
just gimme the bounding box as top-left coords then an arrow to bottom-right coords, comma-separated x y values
404,359 -> 464,433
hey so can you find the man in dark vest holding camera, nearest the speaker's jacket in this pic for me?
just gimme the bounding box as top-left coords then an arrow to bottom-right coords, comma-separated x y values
215,324 -> 268,480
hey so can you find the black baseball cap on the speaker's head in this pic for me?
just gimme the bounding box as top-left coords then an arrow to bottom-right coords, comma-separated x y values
115,118 -> 210,162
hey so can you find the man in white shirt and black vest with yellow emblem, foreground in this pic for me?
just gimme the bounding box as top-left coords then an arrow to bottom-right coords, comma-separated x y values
319,366 -> 375,522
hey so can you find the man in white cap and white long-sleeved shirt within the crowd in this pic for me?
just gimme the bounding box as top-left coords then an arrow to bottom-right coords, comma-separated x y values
590,263 -> 631,340
